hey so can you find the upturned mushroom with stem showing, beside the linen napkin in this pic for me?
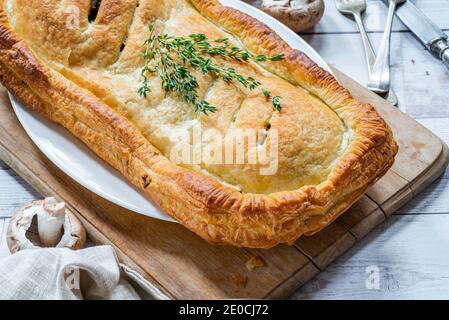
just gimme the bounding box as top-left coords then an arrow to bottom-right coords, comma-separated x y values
7,197 -> 86,253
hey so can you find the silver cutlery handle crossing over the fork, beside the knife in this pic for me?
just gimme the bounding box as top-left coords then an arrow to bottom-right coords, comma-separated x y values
368,0 -> 405,93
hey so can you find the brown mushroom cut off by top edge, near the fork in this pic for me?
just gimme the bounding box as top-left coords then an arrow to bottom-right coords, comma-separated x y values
261,0 -> 324,32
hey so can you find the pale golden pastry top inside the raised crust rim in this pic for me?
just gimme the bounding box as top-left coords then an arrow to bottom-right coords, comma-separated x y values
6,0 -> 350,193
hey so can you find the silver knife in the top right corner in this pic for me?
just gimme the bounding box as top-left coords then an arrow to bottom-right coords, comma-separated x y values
384,0 -> 449,69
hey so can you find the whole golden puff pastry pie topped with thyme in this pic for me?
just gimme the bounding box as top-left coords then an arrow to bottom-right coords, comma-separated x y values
0,0 -> 397,248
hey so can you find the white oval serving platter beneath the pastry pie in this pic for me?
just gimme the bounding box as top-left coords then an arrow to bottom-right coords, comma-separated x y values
10,0 -> 331,221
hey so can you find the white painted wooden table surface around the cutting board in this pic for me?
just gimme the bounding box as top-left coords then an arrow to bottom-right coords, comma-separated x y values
0,0 -> 449,299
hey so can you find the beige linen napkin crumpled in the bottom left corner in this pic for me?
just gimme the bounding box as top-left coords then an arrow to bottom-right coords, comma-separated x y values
0,246 -> 167,300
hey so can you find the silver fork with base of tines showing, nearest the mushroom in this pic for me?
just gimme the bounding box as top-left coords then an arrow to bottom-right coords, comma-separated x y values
335,0 -> 398,105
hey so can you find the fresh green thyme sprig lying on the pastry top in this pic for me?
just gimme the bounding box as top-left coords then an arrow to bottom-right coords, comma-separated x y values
138,25 -> 284,115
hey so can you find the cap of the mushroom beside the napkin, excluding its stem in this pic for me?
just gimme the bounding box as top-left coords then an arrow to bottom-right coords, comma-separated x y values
6,200 -> 86,253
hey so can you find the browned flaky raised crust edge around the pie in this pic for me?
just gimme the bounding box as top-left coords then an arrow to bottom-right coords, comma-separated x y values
0,0 -> 398,248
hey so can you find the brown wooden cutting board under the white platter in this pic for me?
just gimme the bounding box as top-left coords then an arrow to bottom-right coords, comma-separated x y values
0,70 -> 449,299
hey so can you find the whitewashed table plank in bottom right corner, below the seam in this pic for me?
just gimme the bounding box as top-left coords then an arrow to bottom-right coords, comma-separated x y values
291,214 -> 449,299
